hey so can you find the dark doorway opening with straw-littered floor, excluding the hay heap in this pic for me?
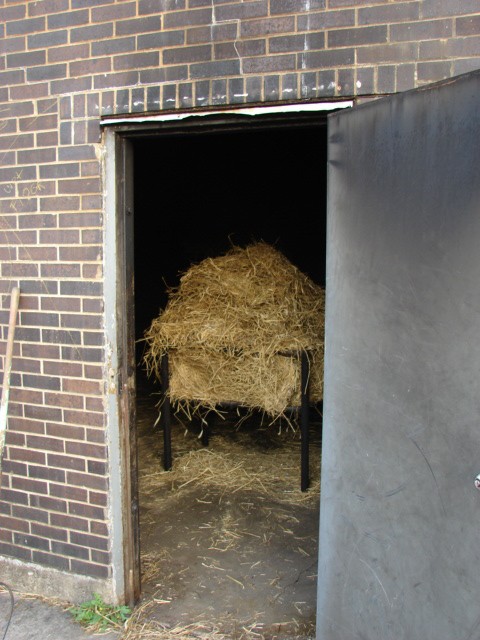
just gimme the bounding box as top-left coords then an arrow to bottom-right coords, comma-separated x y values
130,113 -> 327,638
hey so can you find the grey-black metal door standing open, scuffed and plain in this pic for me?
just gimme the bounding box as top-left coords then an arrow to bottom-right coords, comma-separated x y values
317,72 -> 480,640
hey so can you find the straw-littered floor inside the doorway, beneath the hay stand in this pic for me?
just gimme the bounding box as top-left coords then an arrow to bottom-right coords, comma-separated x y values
126,386 -> 321,640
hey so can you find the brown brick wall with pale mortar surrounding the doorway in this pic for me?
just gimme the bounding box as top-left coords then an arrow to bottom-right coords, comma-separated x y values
0,0 -> 480,596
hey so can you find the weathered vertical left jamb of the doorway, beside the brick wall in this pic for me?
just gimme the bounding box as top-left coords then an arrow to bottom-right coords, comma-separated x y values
104,128 -> 140,606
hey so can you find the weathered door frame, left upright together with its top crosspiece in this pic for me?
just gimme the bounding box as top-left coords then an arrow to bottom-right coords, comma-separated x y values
102,100 -> 352,605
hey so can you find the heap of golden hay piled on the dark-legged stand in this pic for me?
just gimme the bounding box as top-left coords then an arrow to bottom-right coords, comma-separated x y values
144,242 -> 325,419
